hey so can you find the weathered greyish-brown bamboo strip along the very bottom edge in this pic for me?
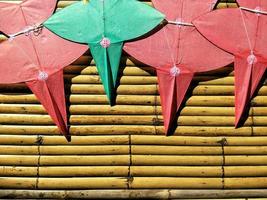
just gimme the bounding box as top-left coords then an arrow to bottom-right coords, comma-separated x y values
0,189 -> 267,200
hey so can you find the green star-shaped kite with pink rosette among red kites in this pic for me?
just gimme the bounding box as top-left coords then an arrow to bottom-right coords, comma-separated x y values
44,0 -> 164,105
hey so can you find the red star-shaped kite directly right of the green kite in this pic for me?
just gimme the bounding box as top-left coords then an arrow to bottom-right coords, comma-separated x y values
124,0 -> 233,134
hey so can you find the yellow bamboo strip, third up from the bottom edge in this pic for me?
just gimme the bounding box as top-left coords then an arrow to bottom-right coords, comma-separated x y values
3,166 -> 267,177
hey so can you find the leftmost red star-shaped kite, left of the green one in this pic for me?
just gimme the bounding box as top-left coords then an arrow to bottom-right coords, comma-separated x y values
0,0 -> 88,139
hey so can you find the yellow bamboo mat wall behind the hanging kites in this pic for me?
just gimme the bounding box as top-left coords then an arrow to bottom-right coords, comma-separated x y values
0,0 -> 267,199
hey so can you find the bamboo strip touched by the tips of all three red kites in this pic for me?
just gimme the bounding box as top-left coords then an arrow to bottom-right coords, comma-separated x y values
0,125 -> 254,137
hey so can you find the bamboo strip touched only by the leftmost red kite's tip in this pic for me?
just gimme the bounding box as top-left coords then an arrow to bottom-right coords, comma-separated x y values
5,134 -> 267,145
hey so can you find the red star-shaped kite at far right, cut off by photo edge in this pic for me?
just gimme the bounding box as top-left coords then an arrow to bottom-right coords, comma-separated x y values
194,0 -> 267,127
